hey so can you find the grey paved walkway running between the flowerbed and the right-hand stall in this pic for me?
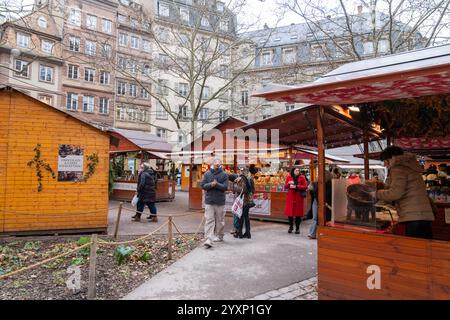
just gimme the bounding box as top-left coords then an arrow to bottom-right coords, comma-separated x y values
124,221 -> 317,300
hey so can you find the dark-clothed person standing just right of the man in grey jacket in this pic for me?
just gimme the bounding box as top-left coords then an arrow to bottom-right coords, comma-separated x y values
234,169 -> 255,239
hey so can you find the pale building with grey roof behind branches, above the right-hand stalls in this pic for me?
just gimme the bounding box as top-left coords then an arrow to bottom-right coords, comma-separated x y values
231,12 -> 423,122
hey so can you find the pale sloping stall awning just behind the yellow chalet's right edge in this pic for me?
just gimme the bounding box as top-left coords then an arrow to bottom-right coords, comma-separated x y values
110,128 -> 172,156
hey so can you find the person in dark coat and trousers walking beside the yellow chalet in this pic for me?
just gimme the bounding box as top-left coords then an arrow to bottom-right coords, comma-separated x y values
132,163 -> 158,222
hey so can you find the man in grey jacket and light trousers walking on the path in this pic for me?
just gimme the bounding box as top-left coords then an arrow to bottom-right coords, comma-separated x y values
202,159 -> 228,248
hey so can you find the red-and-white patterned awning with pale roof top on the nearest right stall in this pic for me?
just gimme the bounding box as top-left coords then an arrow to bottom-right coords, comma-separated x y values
252,45 -> 450,105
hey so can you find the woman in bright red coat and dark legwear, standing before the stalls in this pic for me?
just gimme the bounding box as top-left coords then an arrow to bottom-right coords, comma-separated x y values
284,168 -> 308,234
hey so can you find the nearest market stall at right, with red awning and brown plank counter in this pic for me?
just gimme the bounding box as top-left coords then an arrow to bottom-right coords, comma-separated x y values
256,45 -> 450,300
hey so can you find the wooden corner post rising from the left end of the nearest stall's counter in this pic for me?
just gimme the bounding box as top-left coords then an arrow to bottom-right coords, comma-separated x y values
317,106 -> 326,226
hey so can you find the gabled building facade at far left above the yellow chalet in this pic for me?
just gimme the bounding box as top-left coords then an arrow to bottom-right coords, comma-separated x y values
0,2 -> 64,106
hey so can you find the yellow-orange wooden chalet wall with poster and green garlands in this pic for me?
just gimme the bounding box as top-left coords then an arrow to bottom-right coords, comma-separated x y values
0,90 -> 109,233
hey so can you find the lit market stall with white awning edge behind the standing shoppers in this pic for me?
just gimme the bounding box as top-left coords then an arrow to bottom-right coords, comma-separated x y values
176,115 -> 348,221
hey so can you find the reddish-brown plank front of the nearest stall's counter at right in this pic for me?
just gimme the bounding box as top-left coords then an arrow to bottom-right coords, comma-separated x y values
318,227 -> 450,299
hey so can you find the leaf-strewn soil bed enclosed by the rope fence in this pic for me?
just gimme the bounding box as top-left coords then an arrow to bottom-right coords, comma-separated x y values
0,235 -> 199,300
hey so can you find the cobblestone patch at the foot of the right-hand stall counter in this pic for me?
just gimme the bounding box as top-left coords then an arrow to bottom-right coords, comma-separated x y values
248,277 -> 317,300
